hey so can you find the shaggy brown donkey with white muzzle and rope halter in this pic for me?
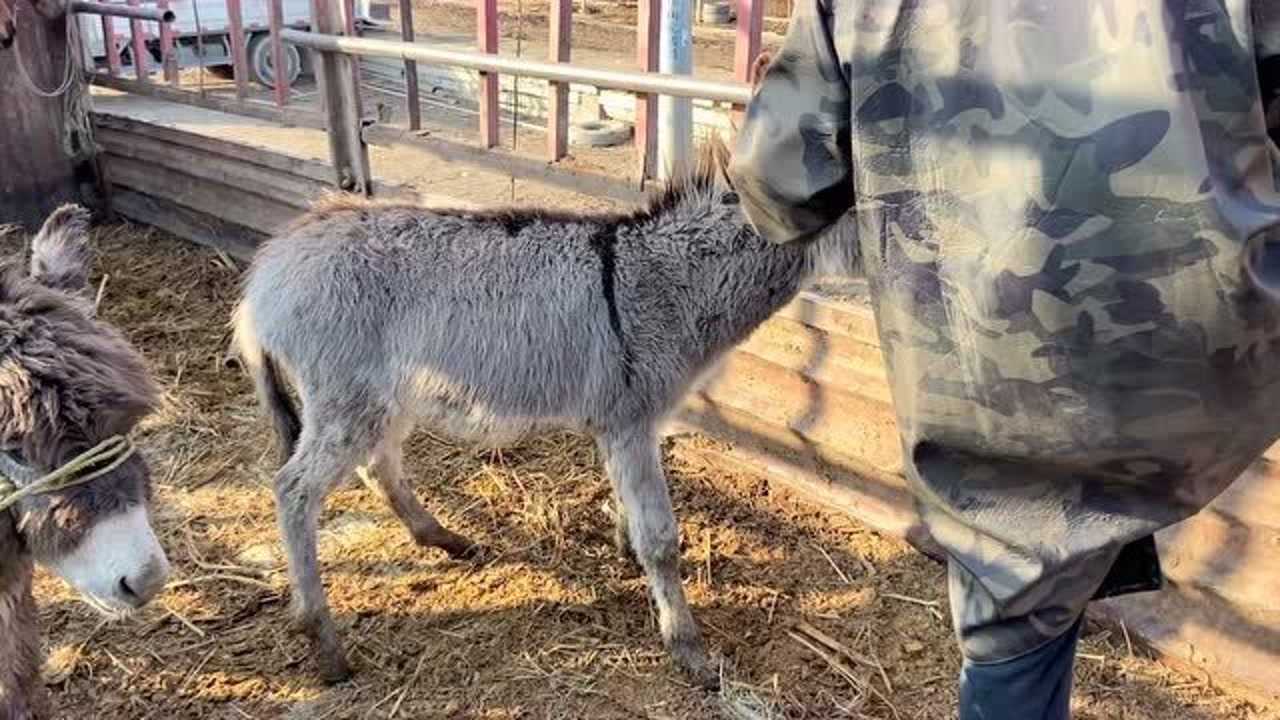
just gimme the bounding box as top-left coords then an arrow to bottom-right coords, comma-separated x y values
0,205 -> 169,720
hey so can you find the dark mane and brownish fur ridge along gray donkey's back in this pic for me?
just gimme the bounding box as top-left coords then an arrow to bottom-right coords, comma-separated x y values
290,137 -> 728,234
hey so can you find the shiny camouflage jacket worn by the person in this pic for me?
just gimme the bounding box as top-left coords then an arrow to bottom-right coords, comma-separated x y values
731,0 -> 1280,656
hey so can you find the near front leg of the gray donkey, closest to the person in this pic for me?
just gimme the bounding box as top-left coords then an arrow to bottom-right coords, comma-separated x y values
599,425 -> 719,689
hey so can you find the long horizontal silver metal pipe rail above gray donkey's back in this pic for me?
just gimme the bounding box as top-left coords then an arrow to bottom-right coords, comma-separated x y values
280,28 -> 751,105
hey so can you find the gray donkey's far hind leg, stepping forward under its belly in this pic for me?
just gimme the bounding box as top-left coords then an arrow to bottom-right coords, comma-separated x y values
356,421 -> 481,560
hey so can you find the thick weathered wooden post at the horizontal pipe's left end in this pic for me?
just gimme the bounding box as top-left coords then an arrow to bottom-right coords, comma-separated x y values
311,0 -> 371,195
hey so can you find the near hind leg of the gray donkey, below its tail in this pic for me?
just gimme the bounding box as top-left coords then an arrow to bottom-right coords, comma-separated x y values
275,428 -> 366,683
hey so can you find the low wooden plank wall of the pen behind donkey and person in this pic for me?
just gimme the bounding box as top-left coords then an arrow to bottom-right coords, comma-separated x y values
96,117 -> 1280,697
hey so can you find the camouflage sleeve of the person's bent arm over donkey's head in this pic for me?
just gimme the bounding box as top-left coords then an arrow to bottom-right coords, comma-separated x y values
730,0 -> 854,243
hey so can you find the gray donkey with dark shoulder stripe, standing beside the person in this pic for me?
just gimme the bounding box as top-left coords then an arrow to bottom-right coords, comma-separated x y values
233,145 -> 852,687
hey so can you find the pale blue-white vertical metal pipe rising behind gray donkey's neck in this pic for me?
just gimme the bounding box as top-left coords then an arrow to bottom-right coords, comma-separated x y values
658,0 -> 694,181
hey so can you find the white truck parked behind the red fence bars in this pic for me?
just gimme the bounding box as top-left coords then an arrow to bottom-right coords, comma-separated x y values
79,0 -> 381,87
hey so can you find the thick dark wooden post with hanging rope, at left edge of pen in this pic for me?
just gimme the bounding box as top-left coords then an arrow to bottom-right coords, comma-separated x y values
0,8 -> 96,224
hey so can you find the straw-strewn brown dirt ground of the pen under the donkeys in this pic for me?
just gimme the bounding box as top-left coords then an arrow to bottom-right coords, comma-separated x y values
10,220 -> 1280,720
